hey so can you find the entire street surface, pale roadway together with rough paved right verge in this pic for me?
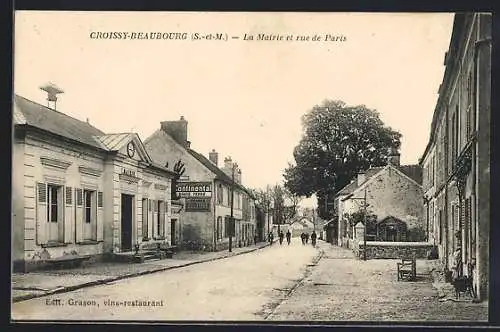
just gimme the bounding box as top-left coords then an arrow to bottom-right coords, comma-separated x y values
12,238 -> 488,321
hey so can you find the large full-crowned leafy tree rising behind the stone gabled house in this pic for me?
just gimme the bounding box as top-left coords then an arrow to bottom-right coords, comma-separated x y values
283,100 -> 401,219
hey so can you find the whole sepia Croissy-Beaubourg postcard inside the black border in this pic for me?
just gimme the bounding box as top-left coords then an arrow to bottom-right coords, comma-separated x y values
11,10 -> 492,325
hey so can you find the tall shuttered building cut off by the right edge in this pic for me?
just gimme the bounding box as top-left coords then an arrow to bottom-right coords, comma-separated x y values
420,13 -> 492,300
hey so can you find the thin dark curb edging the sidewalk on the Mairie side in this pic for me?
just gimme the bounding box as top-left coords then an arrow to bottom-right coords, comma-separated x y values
12,244 -> 269,303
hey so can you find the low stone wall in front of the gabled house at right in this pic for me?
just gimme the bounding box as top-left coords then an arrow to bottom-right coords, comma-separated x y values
353,241 -> 435,259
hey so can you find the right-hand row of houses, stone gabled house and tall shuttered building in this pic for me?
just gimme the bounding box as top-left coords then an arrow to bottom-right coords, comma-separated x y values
325,13 -> 492,300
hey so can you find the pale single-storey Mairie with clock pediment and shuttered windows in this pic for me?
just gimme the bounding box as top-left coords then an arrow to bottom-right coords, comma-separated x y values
12,95 -> 175,271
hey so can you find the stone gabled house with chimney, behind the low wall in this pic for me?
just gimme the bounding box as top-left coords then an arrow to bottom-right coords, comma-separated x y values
335,152 -> 425,247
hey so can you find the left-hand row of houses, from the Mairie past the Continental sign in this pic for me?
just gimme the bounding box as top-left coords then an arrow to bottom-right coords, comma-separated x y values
12,90 -> 265,271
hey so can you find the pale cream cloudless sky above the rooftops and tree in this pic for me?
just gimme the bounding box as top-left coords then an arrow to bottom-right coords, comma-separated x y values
14,11 -> 453,206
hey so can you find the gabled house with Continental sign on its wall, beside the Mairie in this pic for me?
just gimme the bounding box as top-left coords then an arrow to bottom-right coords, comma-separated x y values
144,117 -> 256,251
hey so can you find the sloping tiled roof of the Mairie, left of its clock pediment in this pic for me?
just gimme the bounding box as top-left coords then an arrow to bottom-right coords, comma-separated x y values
13,95 -> 104,149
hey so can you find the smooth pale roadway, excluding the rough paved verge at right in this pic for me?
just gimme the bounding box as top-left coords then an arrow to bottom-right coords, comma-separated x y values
12,239 -> 319,320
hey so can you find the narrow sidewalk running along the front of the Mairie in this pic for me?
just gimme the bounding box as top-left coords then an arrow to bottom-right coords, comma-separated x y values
11,242 -> 268,302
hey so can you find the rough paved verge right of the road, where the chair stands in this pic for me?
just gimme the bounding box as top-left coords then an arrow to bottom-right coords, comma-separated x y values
268,241 -> 488,322
